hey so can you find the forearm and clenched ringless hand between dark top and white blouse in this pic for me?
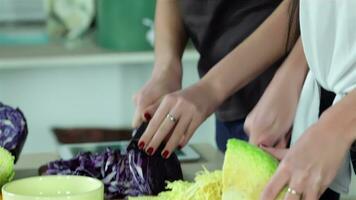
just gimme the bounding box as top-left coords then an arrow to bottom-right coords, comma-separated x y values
244,39 -> 308,146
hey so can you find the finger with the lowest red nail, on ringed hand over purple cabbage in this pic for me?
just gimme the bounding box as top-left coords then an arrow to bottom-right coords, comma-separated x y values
162,117 -> 191,159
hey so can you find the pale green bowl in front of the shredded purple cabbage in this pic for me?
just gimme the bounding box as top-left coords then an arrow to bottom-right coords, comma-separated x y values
2,176 -> 104,200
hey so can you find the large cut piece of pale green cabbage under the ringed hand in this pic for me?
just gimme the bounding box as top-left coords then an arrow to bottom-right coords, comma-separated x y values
222,139 -> 284,200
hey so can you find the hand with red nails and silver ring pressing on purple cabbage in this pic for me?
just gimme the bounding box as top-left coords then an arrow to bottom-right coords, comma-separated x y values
139,82 -> 218,158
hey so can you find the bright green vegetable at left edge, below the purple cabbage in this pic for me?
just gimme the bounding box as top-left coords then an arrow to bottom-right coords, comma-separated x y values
0,147 -> 15,188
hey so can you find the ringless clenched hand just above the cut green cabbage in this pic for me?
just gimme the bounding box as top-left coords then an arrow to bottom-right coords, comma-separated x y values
244,80 -> 298,148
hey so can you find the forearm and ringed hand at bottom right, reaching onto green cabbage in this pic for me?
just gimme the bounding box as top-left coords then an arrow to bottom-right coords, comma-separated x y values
262,89 -> 356,200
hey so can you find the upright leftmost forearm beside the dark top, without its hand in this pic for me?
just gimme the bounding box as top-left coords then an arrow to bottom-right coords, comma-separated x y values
153,0 -> 187,79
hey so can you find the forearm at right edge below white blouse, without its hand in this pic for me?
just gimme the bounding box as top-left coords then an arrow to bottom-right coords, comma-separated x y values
316,89 -> 356,146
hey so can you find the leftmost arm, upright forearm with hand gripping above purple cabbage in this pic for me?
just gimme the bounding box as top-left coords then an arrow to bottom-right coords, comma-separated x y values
132,0 -> 187,127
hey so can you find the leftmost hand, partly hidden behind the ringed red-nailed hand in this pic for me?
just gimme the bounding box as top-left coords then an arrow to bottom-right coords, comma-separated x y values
132,67 -> 182,128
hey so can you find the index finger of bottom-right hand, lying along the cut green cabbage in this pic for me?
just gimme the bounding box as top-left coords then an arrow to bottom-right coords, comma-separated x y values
261,164 -> 290,200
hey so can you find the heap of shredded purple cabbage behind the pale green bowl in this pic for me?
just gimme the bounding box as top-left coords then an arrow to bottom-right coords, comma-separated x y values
45,148 -> 183,199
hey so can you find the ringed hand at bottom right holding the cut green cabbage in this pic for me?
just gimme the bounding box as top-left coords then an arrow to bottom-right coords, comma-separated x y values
261,125 -> 350,200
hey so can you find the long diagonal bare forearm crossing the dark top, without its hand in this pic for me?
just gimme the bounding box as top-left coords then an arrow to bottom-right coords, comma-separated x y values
202,0 -> 291,102
